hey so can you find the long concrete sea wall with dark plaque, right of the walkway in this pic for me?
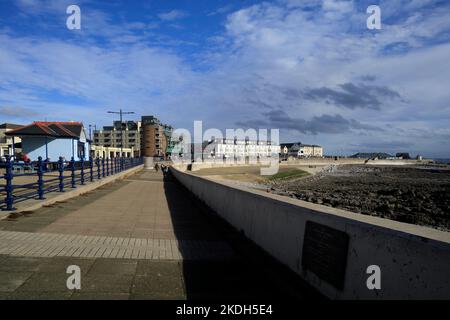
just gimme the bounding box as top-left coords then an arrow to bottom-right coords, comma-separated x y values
171,167 -> 450,299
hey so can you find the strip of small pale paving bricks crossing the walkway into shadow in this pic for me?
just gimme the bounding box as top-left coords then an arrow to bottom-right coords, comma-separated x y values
0,231 -> 233,260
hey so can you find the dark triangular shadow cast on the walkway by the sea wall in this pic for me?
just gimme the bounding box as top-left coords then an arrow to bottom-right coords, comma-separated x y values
164,172 -> 323,302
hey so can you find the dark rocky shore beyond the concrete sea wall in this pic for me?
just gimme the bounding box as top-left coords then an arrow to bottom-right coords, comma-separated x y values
271,165 -> 450,231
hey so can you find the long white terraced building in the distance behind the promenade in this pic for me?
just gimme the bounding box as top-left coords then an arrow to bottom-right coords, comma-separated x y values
203,139 -> 280,161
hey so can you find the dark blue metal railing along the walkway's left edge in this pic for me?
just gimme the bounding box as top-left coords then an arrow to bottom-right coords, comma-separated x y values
0,156 -> 143,211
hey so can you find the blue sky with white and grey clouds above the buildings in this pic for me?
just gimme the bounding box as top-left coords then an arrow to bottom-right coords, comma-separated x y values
0,0 -> 450,158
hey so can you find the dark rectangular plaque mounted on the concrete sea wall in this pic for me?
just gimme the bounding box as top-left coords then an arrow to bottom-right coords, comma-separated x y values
302,221 -> 349,290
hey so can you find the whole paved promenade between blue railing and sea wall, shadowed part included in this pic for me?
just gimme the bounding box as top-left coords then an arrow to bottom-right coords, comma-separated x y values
0,171 -> 316,301
